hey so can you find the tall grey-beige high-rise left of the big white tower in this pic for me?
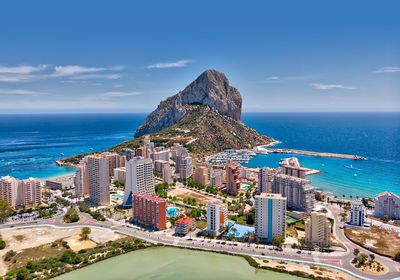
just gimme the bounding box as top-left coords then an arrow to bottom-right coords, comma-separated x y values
87,155 -> 110,205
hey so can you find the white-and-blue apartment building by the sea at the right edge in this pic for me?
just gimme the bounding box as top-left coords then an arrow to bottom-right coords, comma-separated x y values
374,192 -> 400,220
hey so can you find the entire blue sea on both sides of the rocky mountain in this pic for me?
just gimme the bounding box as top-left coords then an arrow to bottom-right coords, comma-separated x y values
0,113 -> 400,198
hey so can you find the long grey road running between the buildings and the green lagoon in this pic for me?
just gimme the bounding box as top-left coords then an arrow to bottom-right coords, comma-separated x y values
0,210 -> 400,280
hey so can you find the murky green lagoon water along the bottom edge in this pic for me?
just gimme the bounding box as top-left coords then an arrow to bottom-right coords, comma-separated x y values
56,248 -> 300,280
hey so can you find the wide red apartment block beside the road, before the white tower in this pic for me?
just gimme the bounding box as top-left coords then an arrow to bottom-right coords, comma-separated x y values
132,193 -> 167,230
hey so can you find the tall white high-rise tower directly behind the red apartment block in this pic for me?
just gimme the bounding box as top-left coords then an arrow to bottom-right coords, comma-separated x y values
123,157 -> 155,207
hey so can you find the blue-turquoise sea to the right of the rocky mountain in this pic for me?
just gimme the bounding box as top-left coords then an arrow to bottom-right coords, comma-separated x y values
244,113 -> 400,198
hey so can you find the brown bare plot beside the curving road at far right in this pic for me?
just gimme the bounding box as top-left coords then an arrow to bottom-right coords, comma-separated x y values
344,226 -> 400,257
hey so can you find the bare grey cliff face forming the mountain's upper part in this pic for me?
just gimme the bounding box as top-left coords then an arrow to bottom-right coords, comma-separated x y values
135,70 -> 242,137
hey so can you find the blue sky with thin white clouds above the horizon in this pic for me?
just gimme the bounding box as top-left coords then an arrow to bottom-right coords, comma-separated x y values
0,0 -> 400,113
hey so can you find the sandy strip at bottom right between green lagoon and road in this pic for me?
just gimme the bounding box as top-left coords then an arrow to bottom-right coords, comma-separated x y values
255,258 -> 356,280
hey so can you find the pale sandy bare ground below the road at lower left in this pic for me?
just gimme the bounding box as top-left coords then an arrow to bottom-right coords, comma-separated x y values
0,227 -> 122,275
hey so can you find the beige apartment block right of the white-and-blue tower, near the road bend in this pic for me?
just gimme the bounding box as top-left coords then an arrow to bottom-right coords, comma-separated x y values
304,212 -> 331,247
